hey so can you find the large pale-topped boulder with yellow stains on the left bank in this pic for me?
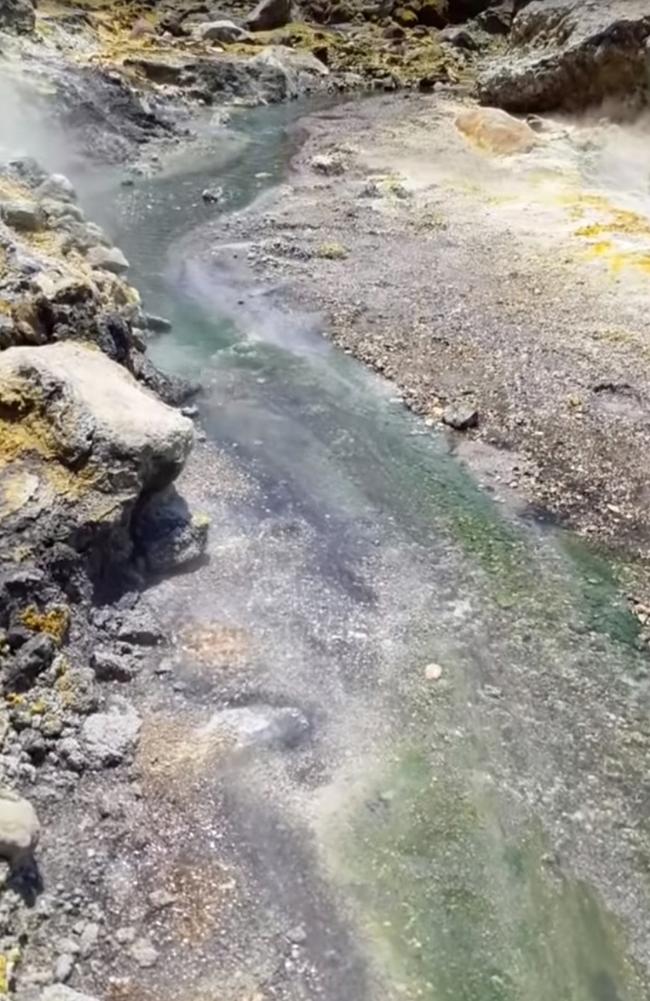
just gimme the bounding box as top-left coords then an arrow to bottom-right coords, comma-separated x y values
0,341 -> 193,572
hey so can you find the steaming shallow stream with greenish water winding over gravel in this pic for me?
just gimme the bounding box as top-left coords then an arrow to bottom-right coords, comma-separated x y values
76,106 -> 650,1001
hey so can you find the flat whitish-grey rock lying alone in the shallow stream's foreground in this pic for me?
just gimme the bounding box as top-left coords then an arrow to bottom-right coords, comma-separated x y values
198,706 -> 310,748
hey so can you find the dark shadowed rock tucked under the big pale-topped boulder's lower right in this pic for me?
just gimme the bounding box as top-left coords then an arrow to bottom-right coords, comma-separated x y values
134,487 -> 209,574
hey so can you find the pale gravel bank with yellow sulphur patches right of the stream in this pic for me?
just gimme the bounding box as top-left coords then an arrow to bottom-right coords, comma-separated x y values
201,94 -> 650,580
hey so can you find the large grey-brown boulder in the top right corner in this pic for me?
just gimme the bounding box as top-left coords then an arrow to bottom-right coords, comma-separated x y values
479,0 -> 650,112
